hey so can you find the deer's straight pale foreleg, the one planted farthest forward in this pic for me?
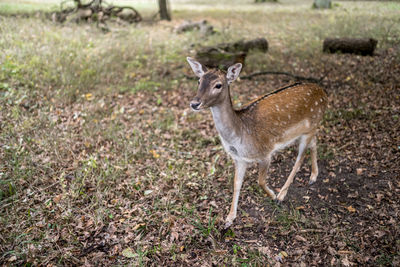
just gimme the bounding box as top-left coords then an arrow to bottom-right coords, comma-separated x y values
225,160 -> 247,228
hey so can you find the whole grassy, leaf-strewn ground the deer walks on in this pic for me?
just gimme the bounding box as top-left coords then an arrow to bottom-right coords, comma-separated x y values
0,1 -> 400,266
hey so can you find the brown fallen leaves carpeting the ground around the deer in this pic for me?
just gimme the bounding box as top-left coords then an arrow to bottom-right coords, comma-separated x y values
0,17 -> 400,266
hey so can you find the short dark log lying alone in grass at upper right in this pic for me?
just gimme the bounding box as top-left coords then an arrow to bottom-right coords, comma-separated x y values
322,38 -> 378,56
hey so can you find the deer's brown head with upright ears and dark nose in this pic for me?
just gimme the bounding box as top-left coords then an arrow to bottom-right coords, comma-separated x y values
187,57 -> 242,111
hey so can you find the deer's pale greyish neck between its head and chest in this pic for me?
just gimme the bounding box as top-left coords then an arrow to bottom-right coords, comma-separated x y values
211,90 -> 242,142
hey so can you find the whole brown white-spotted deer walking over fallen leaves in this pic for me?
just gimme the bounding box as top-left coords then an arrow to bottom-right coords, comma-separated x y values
187,57 -> 328,229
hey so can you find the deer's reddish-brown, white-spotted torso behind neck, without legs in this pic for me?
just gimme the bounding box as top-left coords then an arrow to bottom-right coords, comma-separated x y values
237,84 -> 327,150
